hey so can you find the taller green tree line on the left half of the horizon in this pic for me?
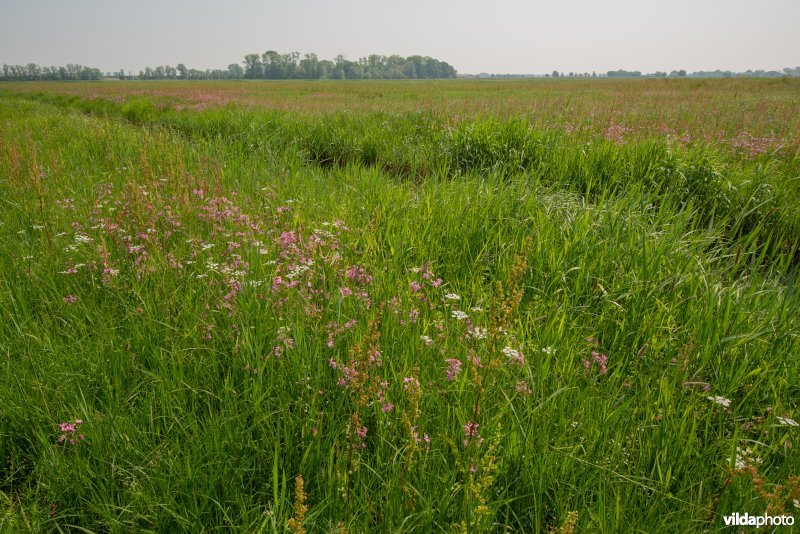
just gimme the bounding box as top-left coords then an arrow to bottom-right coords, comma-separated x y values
0,50 -> 456,81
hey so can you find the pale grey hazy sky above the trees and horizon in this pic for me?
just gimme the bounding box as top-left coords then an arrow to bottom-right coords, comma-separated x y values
0,0 -> 800,73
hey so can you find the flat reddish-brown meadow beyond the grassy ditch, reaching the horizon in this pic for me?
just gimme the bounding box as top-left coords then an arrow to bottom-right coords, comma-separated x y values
6,79 -> 800,151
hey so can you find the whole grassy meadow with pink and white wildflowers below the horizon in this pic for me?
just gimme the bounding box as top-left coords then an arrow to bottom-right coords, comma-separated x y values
0,79 -> 800,532
